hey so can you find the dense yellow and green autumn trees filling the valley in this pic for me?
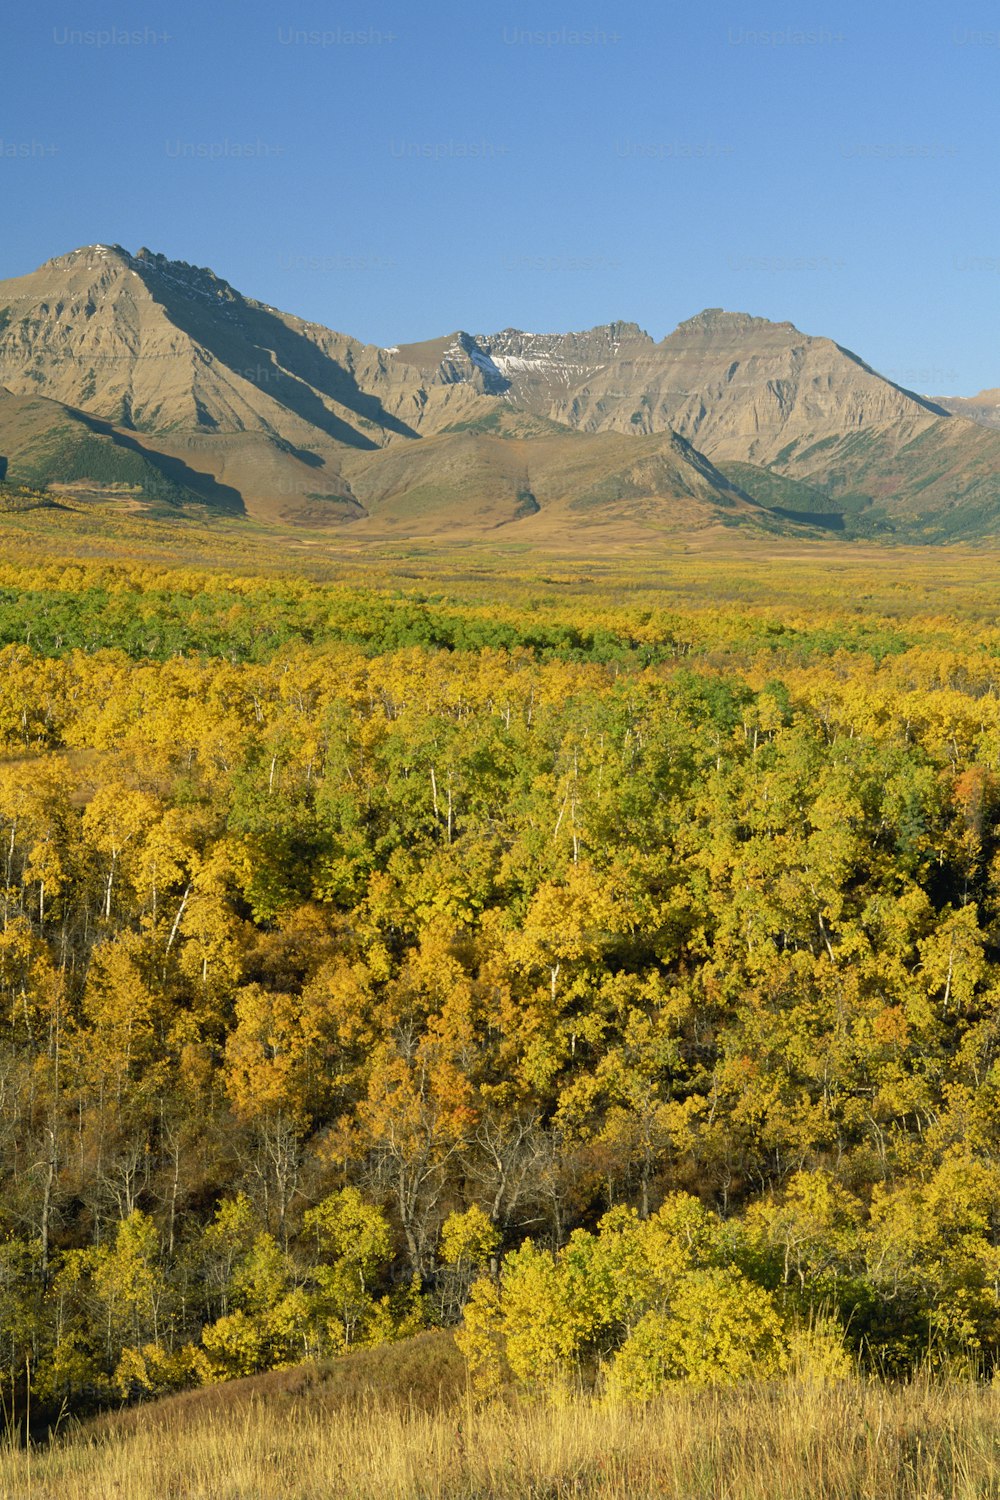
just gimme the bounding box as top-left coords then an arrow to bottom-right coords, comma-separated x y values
0,570 -> 1000,1413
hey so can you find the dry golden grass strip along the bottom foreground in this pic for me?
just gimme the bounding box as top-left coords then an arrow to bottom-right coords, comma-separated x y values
0,1382 -> 1000,1500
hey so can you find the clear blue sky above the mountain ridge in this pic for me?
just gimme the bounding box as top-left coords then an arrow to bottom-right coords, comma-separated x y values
0,0 -> 1000,395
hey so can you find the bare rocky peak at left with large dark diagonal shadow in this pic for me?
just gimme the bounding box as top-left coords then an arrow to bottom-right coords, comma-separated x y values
0,245 -> 406,449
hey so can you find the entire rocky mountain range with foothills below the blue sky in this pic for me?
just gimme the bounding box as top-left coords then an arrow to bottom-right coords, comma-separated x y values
0,245 -> 1000,542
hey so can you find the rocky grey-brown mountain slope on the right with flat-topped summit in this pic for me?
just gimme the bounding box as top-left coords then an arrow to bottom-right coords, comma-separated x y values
464,308 -> 1000,540
